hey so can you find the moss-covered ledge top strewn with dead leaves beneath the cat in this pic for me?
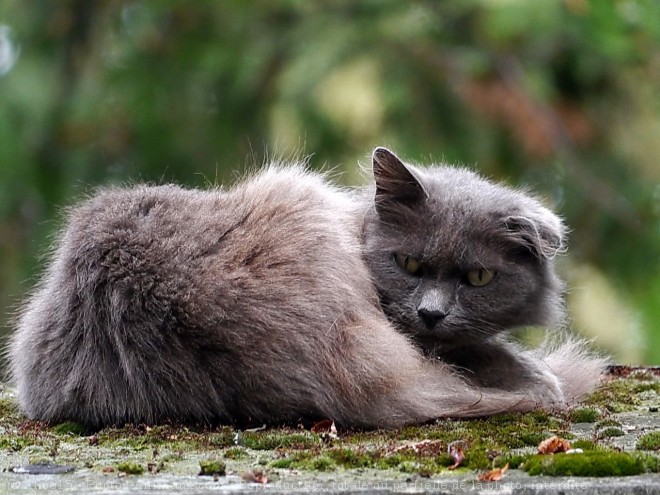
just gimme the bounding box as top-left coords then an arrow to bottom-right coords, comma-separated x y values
0,375 -> 660,477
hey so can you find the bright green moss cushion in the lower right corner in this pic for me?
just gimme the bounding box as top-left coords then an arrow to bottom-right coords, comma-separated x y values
521,450 -> 655,477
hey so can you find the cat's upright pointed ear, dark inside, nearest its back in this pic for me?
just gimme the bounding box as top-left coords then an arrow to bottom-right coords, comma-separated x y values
372,148 -> 428,214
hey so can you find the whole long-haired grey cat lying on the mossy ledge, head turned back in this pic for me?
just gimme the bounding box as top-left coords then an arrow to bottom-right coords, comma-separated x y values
9,148 -> 603,428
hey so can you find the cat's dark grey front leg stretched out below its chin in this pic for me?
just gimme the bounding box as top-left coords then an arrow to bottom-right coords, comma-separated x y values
435,338 -> 565,409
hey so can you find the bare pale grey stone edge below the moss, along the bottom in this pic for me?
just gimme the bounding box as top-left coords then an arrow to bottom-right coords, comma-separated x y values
0,469 -> 660,495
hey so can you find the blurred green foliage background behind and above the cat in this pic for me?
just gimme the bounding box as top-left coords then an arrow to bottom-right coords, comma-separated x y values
0,0 -> 660,364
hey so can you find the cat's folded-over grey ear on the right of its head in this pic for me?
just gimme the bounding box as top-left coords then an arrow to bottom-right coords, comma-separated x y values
504,207 -> 566,259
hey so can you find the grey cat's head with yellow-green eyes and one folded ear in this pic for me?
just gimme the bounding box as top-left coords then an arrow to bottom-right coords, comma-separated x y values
364,148 -> 565,347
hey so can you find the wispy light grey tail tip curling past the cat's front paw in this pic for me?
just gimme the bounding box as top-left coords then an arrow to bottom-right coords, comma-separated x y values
538,334 -> 610,405
